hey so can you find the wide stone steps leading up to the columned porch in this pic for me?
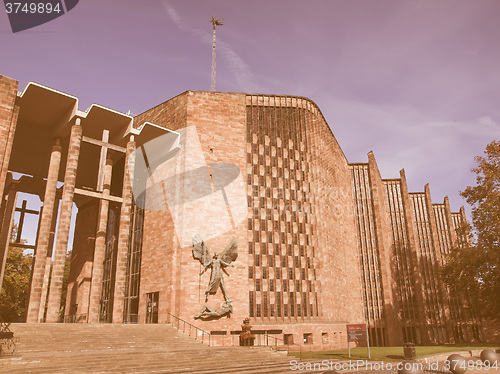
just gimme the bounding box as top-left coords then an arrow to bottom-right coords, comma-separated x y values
0,324 -> 306,374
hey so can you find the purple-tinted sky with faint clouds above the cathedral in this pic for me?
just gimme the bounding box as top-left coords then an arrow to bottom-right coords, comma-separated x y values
0,0 -> 500,245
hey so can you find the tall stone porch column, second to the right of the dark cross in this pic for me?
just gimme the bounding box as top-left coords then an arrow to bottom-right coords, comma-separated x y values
46,118 -> 82,322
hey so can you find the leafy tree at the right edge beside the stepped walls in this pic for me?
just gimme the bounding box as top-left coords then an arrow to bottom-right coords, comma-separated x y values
443,141 -> 500,317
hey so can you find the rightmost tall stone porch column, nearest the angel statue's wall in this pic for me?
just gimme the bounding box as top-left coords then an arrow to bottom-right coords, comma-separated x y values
113,135 -> 135,323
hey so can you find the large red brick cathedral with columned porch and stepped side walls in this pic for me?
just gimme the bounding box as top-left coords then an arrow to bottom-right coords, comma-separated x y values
0,76 -> 482,349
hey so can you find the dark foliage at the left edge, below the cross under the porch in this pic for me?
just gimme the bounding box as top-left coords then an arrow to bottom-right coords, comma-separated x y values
0,247 -> 33,322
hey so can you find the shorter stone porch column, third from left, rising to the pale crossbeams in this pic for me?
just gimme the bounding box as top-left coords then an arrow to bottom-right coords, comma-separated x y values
87,159 -> 113,323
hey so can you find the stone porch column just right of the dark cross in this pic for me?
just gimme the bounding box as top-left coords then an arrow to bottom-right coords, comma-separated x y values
26,139 -> 62,323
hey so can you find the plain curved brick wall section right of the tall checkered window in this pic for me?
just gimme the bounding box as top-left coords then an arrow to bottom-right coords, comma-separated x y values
306,100 -> 364,323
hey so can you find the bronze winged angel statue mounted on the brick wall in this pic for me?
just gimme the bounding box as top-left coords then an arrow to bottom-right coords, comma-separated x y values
193,235 -> 238,302
